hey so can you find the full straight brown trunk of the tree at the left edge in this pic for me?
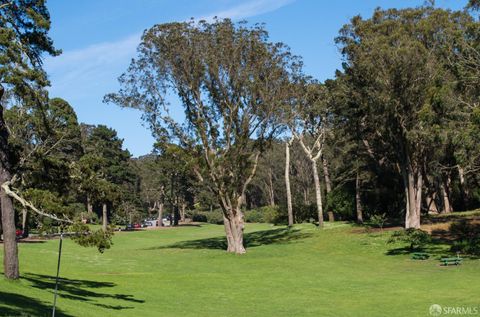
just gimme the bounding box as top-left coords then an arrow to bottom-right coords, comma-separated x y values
0,85 -> 19,279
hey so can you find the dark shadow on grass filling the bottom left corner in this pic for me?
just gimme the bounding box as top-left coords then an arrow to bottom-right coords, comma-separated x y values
0,292 -> 73,317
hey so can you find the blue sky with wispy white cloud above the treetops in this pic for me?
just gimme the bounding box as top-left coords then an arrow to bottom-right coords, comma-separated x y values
45,0 -> 466,156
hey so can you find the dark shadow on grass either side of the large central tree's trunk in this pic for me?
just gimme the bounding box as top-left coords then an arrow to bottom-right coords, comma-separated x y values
147,228 -> 312,250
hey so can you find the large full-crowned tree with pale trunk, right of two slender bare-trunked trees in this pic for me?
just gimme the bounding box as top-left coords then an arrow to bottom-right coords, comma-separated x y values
336,7 -> 470,228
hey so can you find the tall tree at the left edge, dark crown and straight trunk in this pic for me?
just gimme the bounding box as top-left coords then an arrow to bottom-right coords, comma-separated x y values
0,0 -> 59,279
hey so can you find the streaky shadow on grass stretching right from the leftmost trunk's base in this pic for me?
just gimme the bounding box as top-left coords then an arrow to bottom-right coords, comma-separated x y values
21,273 -> 145,310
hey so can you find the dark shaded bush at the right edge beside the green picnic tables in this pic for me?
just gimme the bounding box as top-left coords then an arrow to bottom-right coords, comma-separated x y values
449,219 -> 480,255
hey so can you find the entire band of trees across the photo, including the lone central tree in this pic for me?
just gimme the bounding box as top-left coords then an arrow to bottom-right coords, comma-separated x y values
0,0 -> 480,278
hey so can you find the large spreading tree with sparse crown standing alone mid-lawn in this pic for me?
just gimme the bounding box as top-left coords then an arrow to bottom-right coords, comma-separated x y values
106,19 -> 300,253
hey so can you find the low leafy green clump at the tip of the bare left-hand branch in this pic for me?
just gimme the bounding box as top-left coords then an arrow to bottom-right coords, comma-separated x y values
69,223 -> 113,253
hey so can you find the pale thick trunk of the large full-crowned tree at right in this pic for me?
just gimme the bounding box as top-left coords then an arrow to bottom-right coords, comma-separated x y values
402,165 -> 423,229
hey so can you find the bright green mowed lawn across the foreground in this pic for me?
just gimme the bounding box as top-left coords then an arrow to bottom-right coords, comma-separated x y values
0,223 -> 480,317
